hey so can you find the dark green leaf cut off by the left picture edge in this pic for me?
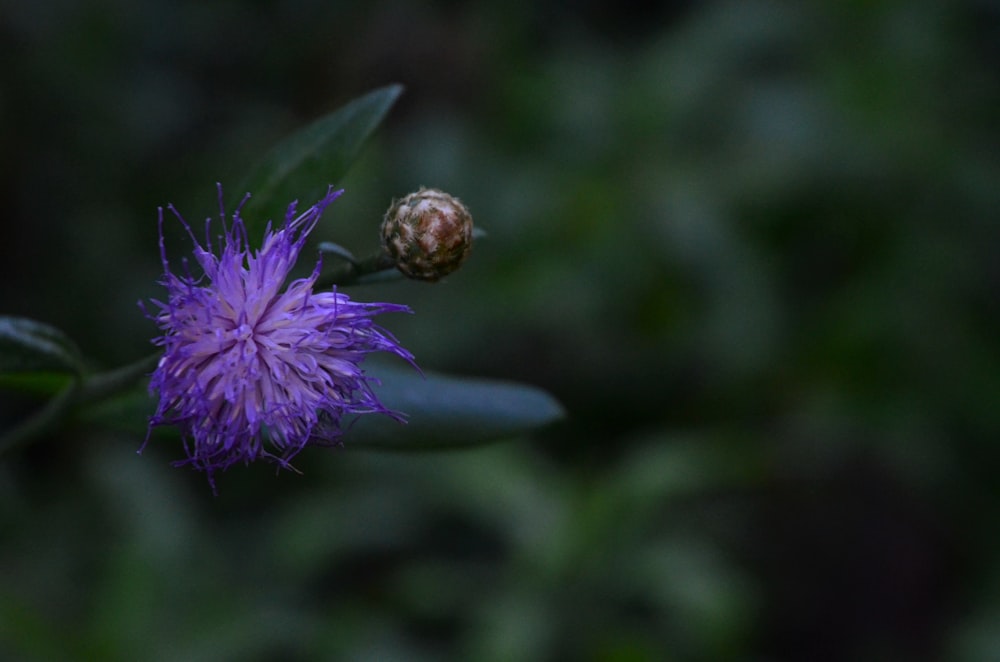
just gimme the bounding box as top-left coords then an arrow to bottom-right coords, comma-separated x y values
0,316 -> 83,375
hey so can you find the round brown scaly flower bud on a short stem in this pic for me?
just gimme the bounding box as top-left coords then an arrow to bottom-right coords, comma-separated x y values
382,188 -> 472,281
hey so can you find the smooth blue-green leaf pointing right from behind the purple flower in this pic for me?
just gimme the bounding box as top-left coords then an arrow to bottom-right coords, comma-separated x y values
344,364 -> 565,451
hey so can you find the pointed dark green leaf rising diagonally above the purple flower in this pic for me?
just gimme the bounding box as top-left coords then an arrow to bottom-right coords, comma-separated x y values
239,85 -> 403,240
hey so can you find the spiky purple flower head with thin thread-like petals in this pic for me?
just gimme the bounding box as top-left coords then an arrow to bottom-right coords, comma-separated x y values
147,186 -> 413,489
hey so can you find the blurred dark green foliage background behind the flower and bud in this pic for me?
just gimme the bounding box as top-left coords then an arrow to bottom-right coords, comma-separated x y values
0,0 -> 1000,661
